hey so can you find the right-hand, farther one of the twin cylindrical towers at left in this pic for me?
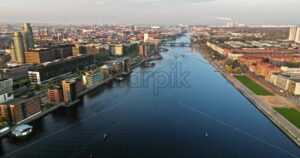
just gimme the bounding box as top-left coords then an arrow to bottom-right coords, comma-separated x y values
23,23 -> 34,51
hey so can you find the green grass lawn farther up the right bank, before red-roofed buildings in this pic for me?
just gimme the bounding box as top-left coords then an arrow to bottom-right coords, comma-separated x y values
234,75 -> 274,96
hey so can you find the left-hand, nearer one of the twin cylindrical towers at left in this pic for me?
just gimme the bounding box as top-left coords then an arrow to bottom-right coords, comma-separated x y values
13,32 -> 25,64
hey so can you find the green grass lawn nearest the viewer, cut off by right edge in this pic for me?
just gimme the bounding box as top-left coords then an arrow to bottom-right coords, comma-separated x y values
274,108 -> 300,129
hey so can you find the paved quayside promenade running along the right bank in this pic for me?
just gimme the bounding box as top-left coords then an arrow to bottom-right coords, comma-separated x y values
199,51 -> 300,148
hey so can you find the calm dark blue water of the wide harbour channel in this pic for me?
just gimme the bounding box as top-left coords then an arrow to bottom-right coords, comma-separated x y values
1,34 -> 300,158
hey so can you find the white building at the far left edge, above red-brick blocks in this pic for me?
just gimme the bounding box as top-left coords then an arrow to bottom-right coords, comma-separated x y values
0,79 -> 14,103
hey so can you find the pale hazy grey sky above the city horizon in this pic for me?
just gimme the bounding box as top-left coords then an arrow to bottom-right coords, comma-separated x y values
0,0 -> 300,26
